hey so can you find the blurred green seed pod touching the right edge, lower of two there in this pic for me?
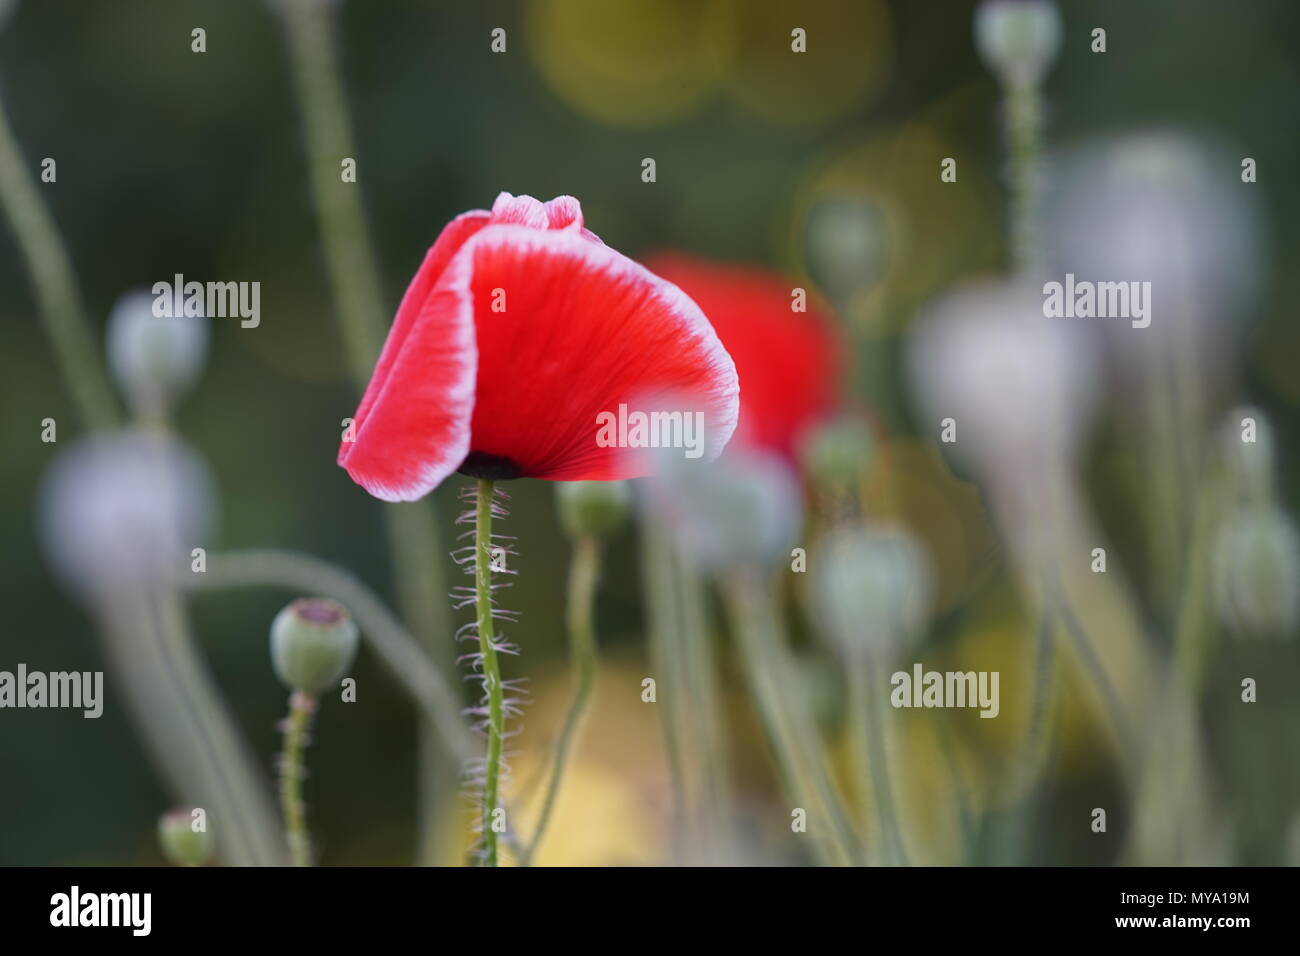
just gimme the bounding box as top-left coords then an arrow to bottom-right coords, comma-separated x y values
1213,507 -> 1300,637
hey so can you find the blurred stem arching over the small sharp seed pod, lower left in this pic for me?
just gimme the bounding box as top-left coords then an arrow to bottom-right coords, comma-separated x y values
181,548 -> 473,760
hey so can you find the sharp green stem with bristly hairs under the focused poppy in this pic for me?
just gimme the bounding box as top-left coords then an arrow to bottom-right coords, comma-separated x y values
451,479 -> 525,866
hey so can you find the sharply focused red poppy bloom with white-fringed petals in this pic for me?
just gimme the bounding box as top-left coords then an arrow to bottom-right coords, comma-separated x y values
338,193 -> 738,501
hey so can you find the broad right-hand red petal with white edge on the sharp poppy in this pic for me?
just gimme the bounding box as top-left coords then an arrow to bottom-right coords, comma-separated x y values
462,223 -> 740,480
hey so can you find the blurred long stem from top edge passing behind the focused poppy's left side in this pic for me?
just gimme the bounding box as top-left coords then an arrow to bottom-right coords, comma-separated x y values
280,0 -> 458,865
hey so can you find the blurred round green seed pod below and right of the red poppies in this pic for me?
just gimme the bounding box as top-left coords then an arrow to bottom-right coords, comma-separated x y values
810,524 -> 931,653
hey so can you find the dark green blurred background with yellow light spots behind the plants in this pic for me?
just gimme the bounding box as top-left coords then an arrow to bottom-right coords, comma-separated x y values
0,0 -> 1300,865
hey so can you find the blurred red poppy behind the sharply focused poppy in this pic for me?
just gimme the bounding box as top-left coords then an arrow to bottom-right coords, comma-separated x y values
647,252 -> 840,462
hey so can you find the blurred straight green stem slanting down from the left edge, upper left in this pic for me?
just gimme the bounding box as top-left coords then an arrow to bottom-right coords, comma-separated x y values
0,85 -> 121,428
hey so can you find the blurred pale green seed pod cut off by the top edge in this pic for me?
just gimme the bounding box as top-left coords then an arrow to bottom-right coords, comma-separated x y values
975,0 -> 1062,86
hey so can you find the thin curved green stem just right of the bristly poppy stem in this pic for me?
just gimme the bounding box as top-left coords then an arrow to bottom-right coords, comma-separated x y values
521,537 -> 601,866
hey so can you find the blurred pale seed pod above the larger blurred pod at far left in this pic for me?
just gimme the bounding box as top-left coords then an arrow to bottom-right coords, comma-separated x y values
108,291 -> 208,414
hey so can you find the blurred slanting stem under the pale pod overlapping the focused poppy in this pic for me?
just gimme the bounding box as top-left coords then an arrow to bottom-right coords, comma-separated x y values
723,572 -> 862,866
